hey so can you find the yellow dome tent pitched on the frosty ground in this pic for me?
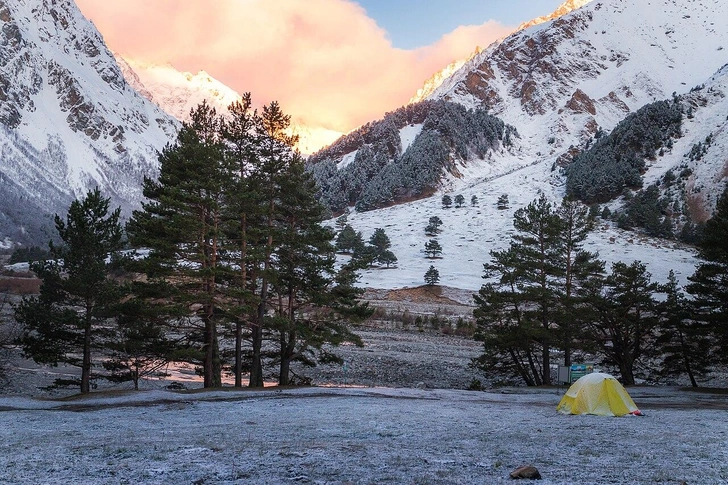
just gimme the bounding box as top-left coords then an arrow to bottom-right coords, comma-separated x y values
556,372 -> 641,416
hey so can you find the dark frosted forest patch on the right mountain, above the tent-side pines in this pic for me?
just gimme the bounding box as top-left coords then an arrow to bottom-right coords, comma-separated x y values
566,98 -> 683,204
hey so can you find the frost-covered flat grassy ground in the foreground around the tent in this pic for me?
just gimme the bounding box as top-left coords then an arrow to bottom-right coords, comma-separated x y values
0,388 -> 728,484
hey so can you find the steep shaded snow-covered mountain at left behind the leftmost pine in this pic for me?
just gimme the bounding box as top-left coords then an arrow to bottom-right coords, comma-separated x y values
0,0 -> 178,244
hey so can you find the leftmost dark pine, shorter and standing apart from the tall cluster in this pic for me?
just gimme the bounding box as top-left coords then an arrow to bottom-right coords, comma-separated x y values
15,188 -> 123,393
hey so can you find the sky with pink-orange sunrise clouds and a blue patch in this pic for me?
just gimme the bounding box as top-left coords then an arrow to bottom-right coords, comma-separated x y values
76,0 -> 562,132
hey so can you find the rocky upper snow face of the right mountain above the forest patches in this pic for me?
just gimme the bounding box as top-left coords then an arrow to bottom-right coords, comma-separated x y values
430,0 -> 728,164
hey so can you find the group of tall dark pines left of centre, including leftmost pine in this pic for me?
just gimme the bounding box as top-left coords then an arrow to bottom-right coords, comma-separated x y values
15,94 -> 370,392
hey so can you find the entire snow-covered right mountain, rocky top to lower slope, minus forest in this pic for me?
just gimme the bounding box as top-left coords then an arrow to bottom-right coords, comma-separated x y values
314,0 -> 728,289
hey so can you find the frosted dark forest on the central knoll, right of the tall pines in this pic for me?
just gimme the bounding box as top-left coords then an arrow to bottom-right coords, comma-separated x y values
308,100 -> 518,212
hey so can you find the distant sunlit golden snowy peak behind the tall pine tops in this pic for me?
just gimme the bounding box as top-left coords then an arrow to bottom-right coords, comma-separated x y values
115,53 -> 342,154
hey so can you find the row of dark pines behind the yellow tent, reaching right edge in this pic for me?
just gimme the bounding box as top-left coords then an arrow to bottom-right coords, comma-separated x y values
474,189 -> 728,386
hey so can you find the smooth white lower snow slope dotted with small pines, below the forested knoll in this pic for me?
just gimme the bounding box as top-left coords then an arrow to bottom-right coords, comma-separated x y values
340,151 -> 696,290
